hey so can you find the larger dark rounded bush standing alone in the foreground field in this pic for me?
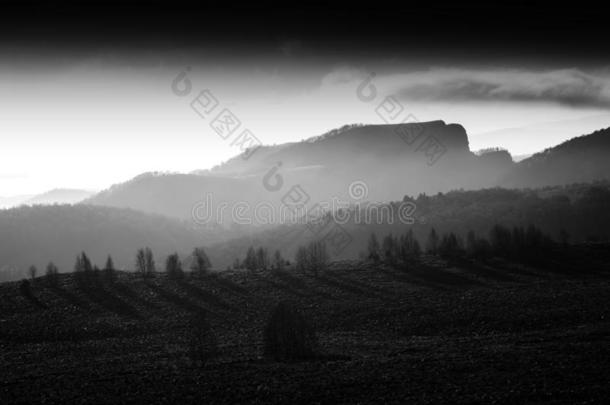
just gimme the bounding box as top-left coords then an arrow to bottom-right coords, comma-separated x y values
263,301 -> 317,361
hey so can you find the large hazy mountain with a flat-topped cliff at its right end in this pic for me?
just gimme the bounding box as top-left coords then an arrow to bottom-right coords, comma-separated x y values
86,121 -> 512,219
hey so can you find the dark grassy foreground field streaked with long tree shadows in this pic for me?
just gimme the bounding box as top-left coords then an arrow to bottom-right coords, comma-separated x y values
0,263 -> 610,404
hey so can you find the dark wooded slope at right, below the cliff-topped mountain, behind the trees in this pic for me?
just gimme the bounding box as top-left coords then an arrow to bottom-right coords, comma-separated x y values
203,182 -> 610,268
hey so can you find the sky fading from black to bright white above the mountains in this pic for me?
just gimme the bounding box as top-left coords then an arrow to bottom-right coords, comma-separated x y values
0,2 -> 610,197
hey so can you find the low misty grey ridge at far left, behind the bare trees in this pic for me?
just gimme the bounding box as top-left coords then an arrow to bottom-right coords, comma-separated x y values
0,204 -> 211,279
